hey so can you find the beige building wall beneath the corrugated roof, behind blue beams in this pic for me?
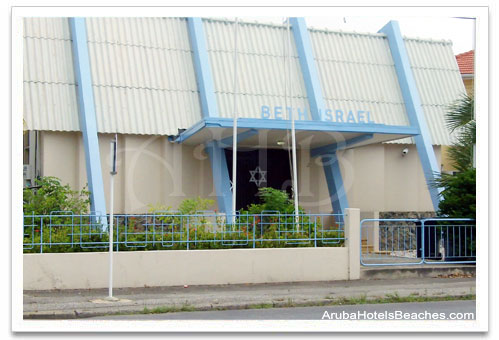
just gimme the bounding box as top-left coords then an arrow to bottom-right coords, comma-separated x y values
41,132 -> 440,213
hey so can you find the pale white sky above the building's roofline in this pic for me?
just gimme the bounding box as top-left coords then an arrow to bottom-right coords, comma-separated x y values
246,17 -> 475,54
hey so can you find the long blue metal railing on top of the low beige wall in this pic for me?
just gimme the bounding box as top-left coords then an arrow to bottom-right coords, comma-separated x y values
23,211 -> 345,253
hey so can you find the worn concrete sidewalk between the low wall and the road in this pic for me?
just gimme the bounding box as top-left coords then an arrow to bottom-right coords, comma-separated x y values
24,278 -> 475,319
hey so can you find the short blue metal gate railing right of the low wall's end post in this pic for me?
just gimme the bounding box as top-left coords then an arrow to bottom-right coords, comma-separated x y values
360,218 -> 476,266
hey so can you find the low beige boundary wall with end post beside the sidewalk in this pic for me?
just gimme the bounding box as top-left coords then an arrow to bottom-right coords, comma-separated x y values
23,209 -> 360,290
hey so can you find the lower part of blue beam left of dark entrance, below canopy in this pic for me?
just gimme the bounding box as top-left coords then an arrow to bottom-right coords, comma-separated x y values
205,141 -> 232,214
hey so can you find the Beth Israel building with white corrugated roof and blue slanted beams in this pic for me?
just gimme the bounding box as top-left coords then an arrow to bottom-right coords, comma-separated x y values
23,18 -> 464,213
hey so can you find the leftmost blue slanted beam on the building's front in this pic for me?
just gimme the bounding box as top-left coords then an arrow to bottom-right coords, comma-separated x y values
69,18 -> 107,229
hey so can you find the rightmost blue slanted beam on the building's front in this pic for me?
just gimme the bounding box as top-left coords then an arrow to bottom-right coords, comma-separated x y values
379,21 -> 440,210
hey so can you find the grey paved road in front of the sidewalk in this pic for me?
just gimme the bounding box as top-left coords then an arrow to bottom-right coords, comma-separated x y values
92,300 -> 476,320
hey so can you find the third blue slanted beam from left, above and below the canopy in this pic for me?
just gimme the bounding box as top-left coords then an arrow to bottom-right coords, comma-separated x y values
290,18 -> 348,213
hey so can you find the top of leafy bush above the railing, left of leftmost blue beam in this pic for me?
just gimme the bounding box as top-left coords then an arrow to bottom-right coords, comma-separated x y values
23,176 -> 90,215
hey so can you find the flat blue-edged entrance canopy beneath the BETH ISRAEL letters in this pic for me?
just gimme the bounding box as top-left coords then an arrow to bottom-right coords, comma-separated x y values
170,118 -> 419,149
